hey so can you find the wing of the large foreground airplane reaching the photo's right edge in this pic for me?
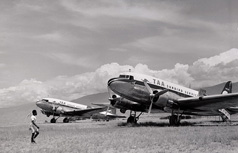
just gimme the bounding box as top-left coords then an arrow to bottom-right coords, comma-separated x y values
175,93 -> 238,111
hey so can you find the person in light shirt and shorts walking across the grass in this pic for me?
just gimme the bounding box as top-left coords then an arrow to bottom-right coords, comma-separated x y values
30,110 -> 39,143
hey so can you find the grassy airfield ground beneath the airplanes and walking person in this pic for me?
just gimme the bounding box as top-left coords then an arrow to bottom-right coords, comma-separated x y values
0,116 -> 238,153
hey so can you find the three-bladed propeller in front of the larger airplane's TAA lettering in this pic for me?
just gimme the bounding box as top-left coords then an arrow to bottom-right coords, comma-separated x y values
143,80 -> 169,114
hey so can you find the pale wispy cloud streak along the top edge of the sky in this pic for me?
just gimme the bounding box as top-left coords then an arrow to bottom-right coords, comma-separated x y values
62,0 -> 178,20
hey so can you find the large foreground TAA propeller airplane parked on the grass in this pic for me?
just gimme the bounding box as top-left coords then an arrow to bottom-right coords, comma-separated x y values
108,72 -> 238,126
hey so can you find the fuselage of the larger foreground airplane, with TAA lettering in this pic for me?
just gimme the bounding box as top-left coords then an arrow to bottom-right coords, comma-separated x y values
108,73 -> 198,107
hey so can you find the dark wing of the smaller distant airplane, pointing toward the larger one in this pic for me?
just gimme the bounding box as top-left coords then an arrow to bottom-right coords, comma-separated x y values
64,107 -> 107,116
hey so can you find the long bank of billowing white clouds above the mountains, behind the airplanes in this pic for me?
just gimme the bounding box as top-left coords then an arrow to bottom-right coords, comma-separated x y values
0,49 -> 238,107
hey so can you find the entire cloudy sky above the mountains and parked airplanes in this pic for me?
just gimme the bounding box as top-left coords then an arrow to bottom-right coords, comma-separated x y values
0,0 -> 238,108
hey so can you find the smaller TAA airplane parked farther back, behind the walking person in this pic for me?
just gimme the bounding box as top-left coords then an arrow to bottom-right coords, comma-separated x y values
36,98 -> 110,123
